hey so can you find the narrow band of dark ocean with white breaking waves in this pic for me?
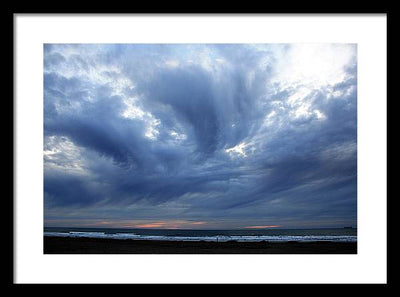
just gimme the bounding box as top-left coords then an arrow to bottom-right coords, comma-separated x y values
44,227 -> 357,242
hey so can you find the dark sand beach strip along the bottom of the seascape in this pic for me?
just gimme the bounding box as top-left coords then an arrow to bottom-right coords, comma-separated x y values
44,236 -> 357,254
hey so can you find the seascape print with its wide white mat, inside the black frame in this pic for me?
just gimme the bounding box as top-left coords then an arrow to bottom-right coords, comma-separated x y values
14,14 -> 387,283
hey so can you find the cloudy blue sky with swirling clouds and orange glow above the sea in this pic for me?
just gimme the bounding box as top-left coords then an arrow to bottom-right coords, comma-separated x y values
43,44 -> 357,229
